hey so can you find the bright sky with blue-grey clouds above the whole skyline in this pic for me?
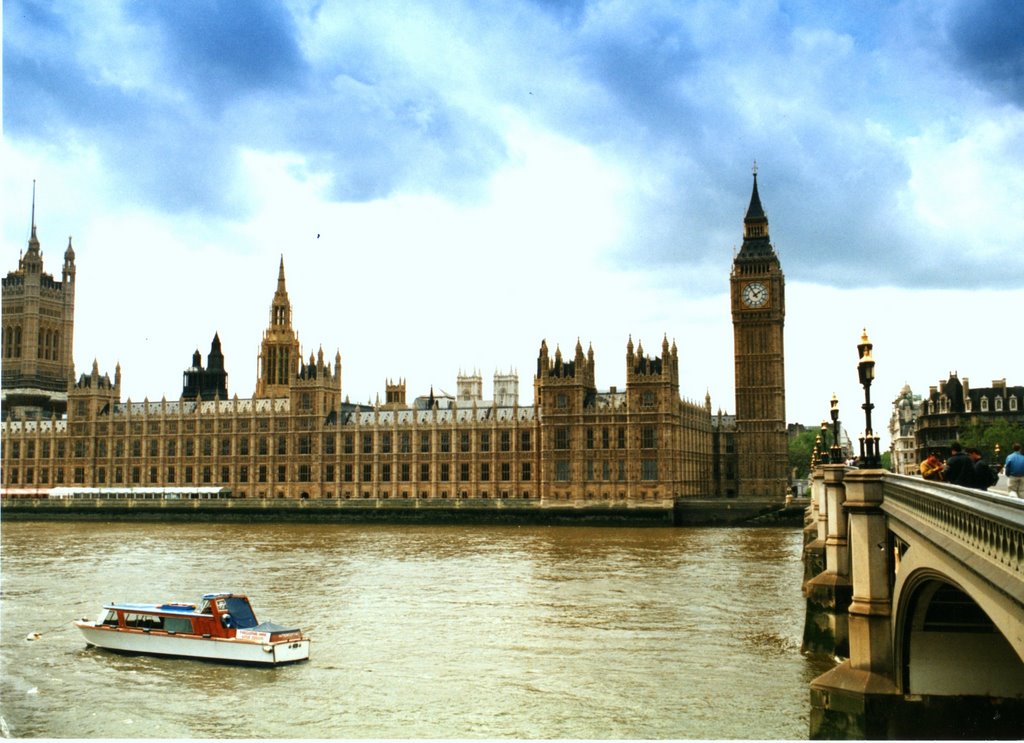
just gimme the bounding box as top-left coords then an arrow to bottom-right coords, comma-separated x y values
0,0 -> 1024,445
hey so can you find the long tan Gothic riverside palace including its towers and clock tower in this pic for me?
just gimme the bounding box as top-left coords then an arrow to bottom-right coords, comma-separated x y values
0,172 -> 788,504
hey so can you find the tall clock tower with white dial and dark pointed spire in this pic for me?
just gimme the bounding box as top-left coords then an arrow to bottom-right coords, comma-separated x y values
729,165 -> 788,498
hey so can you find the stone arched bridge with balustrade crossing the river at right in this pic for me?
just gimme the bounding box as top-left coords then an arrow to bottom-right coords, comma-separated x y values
804,465 -> 1024,739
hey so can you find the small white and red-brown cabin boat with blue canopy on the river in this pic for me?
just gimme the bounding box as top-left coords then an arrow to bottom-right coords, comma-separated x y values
75,594 -> 309,665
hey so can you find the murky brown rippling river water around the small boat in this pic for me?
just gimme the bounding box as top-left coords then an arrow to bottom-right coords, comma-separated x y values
0,522 -> 830,739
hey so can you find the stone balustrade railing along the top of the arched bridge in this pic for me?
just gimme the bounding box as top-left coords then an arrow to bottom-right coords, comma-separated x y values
882,475 -> 1024,580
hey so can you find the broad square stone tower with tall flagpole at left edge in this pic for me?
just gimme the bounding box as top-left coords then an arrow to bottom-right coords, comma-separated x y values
0,186 -> 75,418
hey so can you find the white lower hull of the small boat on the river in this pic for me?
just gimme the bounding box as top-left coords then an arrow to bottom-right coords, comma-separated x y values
75,621 -> 309,665
